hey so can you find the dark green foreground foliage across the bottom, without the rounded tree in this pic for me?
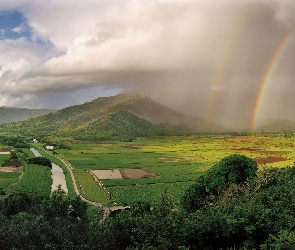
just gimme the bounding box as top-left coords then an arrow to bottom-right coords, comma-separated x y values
0,155 -> 295,250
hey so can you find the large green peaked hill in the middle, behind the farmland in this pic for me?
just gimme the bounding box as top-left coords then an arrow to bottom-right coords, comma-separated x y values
1,94 -> 222,140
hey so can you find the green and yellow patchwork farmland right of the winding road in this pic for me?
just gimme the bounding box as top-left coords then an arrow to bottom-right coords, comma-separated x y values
56,135 -> 295,205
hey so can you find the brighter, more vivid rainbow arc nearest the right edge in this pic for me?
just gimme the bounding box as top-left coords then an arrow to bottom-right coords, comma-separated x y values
251,30 -> 294,132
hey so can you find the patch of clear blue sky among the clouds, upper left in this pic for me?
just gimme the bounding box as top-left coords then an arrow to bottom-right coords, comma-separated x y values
0,11 -> 31,40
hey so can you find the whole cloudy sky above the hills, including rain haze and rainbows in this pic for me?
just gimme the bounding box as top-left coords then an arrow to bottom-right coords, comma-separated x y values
0,0 -> 295,128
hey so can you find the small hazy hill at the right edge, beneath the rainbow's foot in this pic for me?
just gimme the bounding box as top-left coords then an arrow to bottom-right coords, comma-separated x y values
257,119 -> 295,132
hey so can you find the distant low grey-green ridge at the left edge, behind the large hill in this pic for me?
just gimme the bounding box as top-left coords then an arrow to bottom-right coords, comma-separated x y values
0,107 -> 55,124
